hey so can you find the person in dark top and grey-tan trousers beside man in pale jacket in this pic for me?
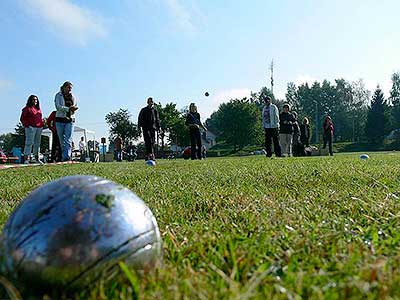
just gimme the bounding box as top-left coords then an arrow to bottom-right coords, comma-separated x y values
279,103 -> 295,156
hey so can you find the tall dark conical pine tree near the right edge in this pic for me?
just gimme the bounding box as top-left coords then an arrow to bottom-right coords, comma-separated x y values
365,86 -> 387,144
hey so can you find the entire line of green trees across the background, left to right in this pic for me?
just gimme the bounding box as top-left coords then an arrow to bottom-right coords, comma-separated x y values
0,72 -> 400,151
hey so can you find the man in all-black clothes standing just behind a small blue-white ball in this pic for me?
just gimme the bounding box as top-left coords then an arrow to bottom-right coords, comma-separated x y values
138,97 -> 160,160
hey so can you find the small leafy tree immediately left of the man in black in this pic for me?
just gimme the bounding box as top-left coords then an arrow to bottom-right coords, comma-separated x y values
105,108 -> 139,143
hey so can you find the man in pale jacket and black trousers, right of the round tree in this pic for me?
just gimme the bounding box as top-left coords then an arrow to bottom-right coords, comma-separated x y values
262,96 -> 281,157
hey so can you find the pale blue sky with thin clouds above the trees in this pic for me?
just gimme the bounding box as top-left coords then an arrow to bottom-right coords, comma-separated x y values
0,0 -> 400,138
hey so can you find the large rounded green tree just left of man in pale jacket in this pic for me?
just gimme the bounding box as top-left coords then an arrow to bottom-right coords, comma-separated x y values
207,98 -> 262,151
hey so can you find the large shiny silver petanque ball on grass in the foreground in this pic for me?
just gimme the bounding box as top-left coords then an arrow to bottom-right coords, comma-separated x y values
0,176 -> 162,291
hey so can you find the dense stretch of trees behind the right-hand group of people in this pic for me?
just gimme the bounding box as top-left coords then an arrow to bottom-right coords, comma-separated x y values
206,72 -> 400,149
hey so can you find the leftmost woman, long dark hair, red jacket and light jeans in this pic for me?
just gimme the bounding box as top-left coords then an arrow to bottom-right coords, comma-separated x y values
20,95 -> 44,164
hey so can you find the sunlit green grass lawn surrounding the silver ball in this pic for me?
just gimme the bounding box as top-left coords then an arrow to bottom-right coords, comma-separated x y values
0,153 -> 400,299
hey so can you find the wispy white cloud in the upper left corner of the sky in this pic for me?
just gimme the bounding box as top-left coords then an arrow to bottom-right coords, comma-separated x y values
23,0 -> 107,45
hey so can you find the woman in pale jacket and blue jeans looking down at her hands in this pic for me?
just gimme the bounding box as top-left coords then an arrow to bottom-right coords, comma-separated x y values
54,81 -> 78,161
